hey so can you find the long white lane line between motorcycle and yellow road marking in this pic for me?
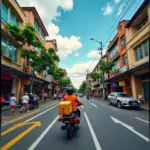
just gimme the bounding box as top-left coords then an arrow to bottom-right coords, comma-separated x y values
28,116 -> 59,150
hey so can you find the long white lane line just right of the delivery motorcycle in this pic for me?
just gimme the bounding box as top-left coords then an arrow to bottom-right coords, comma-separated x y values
84,112 -> 102,150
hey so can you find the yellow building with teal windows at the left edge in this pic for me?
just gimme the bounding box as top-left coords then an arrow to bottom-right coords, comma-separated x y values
1,0 -> 28,100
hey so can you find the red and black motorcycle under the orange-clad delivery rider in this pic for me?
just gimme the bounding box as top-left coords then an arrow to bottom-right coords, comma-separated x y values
58,105 -> 81,139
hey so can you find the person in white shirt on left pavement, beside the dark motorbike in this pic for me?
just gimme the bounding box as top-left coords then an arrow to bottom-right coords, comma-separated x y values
20,93 -> 29,113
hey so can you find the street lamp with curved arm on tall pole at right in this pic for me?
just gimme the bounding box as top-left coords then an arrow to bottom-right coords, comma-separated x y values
90,38 -> 105,98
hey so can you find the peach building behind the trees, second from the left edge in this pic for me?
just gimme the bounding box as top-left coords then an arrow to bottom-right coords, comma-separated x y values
18,7 -> 49,96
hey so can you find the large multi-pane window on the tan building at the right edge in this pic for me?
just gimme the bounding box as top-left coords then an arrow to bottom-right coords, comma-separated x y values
134,40 -> 149,61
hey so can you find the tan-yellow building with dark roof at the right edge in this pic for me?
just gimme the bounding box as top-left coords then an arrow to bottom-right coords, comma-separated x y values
126,0 -> 150,102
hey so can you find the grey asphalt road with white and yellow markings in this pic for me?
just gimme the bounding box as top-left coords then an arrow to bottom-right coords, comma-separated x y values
1,98 -> 150,150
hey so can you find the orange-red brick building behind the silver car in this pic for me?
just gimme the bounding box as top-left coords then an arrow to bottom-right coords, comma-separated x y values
106,20 -> 131,95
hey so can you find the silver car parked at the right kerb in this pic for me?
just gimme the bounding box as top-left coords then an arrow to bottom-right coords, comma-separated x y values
108,92 -> 140,108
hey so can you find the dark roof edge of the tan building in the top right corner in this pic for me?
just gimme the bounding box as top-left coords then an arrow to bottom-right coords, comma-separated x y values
126,0 -> 150,28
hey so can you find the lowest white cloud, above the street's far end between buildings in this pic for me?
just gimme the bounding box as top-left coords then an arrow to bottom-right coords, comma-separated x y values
66,60 -> 98,88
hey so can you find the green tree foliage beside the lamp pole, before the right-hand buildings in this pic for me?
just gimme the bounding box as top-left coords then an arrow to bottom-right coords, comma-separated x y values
99,61 -> 114,73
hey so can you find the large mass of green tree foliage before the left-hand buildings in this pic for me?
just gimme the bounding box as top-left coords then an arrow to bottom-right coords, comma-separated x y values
6,24 -> 60,79
